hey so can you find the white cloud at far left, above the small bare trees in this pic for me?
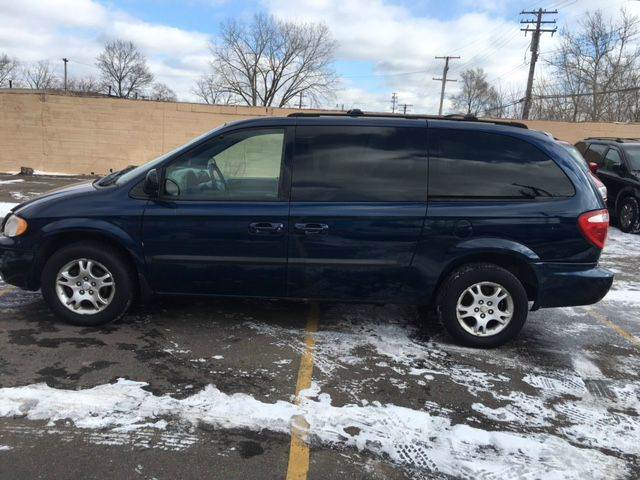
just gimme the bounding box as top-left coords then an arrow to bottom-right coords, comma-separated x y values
0,0 -> 210,100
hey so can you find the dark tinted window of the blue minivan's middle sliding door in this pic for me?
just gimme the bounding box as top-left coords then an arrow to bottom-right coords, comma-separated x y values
291,126 -> 427,202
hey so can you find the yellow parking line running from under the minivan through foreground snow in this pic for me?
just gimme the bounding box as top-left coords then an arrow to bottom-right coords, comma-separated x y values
287,303 -> 320,480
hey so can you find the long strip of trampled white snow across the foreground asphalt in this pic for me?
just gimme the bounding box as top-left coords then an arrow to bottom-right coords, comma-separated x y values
0,379 -> 638,479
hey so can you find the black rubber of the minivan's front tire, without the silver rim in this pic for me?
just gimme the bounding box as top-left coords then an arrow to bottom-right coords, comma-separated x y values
41,242 -> 135,327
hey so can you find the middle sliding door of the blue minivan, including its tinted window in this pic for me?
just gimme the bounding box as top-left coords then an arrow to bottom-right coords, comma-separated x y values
287,122 -> 427,301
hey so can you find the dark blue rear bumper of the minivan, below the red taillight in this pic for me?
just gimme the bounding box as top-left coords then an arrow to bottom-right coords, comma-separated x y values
533,263 -> 613,310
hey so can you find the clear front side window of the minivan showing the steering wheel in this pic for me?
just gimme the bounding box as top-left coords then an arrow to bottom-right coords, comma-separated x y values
164,128 -> 284,201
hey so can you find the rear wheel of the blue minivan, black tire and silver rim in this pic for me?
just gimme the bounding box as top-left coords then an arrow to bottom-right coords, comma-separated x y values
436,263 -> 529,348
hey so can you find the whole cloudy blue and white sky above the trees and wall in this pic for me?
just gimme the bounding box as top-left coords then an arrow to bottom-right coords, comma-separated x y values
0,0 -> 640,113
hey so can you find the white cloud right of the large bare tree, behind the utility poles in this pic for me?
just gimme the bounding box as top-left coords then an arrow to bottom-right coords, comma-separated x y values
265,0 -> 527,113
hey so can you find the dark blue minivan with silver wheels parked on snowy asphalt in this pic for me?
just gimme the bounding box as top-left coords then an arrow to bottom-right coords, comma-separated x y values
0,111 -> 613,347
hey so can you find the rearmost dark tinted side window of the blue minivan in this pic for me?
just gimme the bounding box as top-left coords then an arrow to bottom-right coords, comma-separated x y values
429,129 -> 575,199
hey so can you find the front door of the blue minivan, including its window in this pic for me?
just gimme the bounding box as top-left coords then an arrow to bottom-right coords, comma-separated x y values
143,128 -> 289,297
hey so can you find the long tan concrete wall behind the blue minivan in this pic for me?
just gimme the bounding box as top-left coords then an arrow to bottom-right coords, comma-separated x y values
0,90 -> 640,174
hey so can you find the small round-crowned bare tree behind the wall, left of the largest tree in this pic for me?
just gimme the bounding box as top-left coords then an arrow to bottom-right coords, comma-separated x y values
96,40 -> 153,98
